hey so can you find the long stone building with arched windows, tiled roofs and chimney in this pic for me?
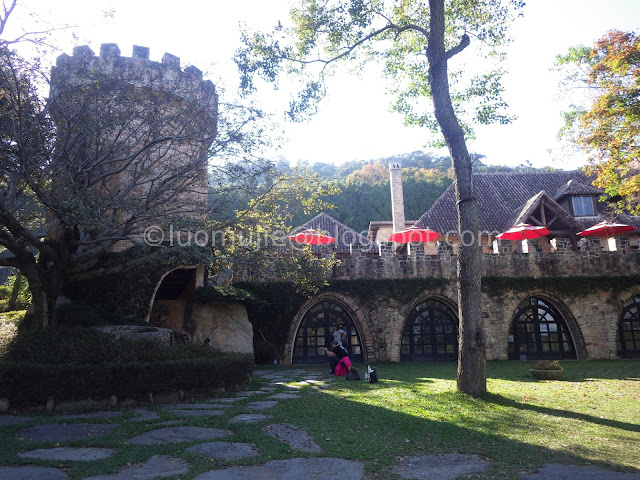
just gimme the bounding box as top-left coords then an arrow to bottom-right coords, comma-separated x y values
238,166 -> 640,363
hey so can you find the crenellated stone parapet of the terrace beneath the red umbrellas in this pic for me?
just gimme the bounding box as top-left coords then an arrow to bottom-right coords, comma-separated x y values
234,234 -> 640,283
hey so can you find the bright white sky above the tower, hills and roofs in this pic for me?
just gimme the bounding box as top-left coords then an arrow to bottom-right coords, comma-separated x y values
5,0 -> 640,169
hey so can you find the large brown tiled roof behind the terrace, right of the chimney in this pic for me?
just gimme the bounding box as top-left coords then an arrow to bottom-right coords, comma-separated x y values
415,170 -> 640,235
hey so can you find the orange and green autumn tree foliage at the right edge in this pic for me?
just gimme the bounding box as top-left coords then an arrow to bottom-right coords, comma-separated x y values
557,30 -> 640,214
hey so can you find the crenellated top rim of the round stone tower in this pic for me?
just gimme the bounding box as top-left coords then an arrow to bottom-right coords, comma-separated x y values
51,43 -> 218,138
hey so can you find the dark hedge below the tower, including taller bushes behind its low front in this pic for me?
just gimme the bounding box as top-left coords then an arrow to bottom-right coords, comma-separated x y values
0,327 -> 254,405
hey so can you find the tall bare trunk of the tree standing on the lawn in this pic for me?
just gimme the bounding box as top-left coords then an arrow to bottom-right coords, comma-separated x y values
427,0 -> 487,395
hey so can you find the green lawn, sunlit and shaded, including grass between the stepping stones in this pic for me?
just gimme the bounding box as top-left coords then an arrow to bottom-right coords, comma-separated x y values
0,361 -> 640,480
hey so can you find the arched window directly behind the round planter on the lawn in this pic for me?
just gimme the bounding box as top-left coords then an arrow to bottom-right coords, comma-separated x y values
509,297 -> 576,360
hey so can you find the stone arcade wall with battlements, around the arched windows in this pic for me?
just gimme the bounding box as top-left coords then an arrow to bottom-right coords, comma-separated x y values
251,239 -> 640,362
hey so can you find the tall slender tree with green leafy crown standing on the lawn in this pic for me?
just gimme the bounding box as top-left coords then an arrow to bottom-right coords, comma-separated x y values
236,0 -> 523,395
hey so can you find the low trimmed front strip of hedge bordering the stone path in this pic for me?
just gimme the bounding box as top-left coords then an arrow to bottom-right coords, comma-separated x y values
0,355 -> 253,405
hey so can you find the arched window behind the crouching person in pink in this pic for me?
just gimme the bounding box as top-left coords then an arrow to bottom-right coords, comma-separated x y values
292,300 -> 364,363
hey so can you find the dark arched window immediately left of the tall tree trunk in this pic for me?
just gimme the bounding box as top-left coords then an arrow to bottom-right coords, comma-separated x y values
400,298 -> 458,362
